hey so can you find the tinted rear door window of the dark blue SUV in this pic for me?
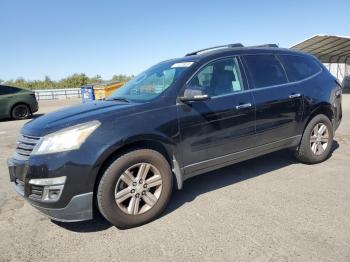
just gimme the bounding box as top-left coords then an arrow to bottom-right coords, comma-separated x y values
244,55 -> 288,88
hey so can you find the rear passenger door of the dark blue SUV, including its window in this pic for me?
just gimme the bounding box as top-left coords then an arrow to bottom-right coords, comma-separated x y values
244,54 -> 303,146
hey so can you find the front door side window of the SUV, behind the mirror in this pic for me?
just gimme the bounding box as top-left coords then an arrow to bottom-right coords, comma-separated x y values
189,58 -> 243,96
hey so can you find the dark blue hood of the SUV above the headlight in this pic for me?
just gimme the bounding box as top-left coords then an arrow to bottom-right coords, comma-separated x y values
21,101 -> 140,137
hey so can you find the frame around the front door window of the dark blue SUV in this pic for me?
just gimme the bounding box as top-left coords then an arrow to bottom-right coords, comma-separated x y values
179,55 -> 251,99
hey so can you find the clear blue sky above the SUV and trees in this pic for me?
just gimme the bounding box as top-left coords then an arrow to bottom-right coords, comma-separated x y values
0,0 -> 350,80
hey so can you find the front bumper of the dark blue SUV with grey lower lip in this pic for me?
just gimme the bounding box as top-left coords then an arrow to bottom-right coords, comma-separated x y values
7,156 -> 93,222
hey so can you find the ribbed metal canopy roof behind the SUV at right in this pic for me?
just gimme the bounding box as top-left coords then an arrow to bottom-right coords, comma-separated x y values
291,35 -> 350,63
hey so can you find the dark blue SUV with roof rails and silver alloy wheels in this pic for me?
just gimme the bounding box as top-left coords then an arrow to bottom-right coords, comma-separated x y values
8,44 -> 342,228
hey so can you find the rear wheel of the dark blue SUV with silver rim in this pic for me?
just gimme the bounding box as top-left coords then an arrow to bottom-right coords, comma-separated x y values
294,114 -> 334,164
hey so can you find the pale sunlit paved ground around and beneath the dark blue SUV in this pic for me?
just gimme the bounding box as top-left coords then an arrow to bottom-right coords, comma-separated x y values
0,95 -> 350,261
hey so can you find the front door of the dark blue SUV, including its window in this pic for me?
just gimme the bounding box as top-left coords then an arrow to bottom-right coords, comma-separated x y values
178,57 -> 255,174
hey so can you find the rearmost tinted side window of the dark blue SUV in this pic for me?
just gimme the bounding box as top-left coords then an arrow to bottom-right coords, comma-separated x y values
280,55 -> 321,81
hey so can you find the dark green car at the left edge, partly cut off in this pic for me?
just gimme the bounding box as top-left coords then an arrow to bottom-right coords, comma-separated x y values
0,85 -> 39,120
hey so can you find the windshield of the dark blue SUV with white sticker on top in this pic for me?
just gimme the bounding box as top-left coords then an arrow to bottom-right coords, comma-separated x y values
106,61 -> 193,102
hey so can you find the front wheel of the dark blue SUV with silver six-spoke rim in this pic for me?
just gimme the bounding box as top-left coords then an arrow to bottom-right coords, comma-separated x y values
97,149 -> 173,228
